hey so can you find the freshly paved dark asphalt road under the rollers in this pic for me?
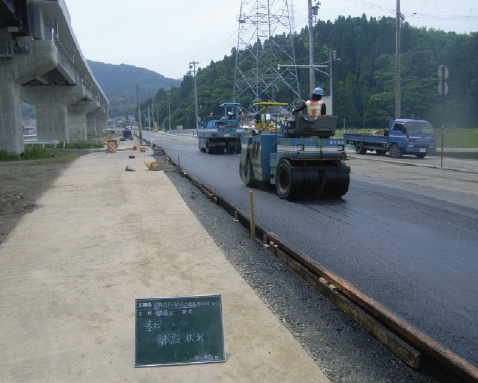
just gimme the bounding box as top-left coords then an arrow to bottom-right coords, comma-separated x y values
143,133 -> 478,366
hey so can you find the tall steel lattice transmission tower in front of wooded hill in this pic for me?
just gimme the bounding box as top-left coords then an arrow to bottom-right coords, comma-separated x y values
234,0 -> 300,107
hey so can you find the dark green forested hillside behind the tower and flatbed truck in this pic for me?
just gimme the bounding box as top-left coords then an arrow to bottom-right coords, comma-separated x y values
142,15 -> 478,128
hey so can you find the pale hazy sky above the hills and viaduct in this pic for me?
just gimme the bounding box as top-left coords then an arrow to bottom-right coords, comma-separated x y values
65,0 -> 478,79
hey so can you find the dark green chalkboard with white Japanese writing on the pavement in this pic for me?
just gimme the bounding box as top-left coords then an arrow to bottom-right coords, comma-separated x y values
135,295 -> 226,367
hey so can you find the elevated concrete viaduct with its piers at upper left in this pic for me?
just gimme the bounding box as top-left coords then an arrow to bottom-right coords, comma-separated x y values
0,0 -> 109,154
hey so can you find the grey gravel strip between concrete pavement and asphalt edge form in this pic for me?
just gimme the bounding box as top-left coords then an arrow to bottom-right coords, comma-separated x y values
161,152 -> 437,383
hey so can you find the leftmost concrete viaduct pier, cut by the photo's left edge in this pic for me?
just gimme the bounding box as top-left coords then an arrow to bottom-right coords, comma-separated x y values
0,59 -> 23,154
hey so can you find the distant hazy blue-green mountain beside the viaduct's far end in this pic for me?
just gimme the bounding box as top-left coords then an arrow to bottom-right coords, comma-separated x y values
87,60 -> 181,117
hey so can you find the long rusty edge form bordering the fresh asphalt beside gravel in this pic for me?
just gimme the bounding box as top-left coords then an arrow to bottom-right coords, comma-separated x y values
161,148 -> 478,383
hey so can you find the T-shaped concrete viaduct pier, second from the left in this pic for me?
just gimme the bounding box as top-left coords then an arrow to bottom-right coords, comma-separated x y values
21,85 -> 85,143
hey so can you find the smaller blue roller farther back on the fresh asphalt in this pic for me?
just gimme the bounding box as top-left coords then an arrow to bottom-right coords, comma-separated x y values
197,102 -> 244,154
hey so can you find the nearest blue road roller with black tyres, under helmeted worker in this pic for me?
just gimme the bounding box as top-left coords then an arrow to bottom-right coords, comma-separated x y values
239,102 -> 350,200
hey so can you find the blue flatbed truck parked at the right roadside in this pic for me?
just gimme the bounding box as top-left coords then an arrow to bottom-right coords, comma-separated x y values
344,119 -> 437,158
